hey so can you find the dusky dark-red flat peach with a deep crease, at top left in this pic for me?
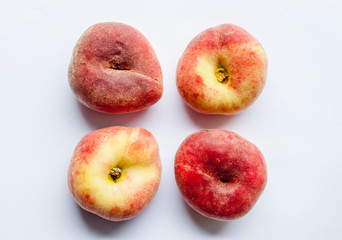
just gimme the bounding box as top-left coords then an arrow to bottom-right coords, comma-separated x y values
68,22 -> 163,113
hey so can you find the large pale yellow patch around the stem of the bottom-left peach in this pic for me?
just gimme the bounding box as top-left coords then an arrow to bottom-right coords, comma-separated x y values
74,128 -> 160,212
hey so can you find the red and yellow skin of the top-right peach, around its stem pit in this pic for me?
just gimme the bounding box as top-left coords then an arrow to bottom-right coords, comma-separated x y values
177,24 -> 267,115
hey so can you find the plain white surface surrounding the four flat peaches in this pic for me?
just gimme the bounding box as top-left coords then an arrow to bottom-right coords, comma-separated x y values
0,0 -> 342,239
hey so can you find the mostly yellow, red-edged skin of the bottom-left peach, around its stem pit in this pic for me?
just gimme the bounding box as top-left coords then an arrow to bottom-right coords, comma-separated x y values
68,127 -> 161,221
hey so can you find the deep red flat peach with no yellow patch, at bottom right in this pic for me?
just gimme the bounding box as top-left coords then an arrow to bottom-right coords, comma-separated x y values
175,130 -> 267,220
